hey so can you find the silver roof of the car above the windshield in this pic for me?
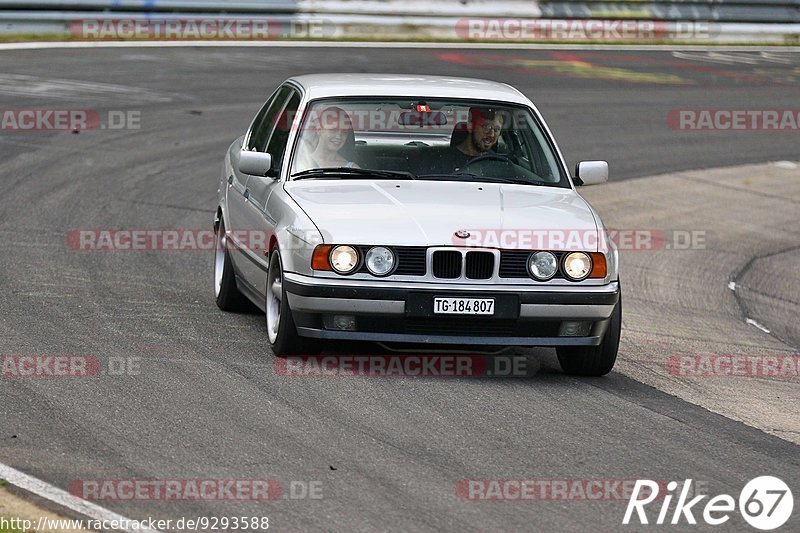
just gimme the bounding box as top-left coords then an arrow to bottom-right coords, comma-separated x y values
288,73 -> 530,105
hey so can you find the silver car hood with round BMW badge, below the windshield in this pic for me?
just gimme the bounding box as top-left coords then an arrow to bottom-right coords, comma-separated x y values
285,180 -> 597,251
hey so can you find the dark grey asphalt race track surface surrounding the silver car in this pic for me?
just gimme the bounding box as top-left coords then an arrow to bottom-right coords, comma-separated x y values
0,47 -> 800,532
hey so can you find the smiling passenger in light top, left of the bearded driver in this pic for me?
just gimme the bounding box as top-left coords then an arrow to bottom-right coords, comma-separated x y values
307,107 -> 360,168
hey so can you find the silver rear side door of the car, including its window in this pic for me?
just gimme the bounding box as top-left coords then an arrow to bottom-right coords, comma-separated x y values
227,86 -> 292,288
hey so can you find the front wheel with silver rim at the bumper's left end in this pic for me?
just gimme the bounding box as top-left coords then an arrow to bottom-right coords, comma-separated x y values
265,248 -> 318,357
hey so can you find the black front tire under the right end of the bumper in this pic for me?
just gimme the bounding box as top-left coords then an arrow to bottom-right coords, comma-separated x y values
556,296 -> 622,376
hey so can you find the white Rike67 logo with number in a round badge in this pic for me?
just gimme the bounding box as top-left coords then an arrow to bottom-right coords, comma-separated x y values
622,476 -> 794,531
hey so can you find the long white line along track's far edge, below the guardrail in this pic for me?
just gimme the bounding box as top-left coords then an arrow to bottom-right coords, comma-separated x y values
0,40 -> 800,52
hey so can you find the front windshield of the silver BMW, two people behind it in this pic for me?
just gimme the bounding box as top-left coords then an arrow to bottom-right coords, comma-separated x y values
291,98 -> 569,187
